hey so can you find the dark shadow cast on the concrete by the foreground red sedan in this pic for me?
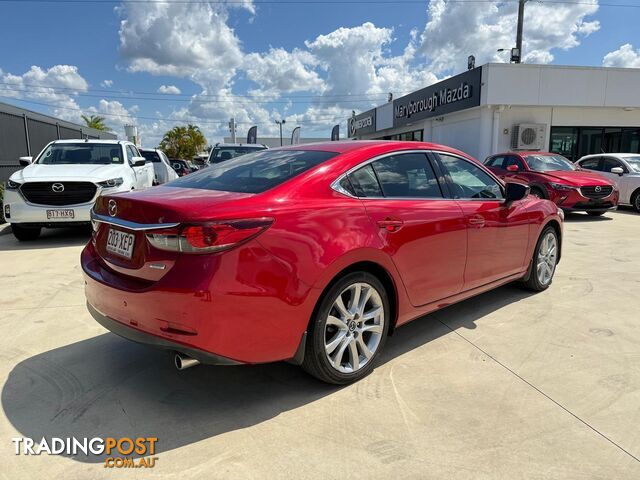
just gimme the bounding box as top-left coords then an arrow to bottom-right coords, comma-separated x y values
1,286 -> 531,463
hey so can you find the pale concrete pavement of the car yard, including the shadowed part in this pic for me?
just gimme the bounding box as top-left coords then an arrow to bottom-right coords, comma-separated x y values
0,211 -> 640,480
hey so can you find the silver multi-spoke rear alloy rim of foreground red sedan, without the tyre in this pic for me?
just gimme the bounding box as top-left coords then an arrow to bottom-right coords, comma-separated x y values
324,282 -> 385,373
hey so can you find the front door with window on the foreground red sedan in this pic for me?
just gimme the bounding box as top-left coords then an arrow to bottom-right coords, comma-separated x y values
438,153 -> 530,290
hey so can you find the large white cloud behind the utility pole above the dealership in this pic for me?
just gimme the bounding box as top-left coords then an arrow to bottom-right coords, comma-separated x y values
420,0 -> 600,74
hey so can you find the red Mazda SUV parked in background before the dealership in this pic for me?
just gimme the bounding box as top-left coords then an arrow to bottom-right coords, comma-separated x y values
484,151 -> 619,216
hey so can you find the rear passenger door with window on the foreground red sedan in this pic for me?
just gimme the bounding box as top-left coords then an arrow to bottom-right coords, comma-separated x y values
348,151 -> 467,306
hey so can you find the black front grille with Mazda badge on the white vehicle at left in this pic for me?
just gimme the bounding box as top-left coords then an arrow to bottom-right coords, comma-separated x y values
20,182 -> 97,207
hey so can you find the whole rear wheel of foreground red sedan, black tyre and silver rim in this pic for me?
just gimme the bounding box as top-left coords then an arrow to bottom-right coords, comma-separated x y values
302,272 -> 391,385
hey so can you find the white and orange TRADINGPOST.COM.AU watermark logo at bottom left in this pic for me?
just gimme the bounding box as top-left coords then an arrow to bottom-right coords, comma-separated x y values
11,437 -> 158,468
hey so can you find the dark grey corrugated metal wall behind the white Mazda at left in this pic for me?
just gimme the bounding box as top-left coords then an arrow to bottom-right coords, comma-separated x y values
0,103 -> 117,182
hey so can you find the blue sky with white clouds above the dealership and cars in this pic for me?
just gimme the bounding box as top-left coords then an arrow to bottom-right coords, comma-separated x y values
0,0 -> 640,145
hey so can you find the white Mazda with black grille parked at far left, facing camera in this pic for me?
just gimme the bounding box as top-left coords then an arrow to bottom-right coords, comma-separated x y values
4,140 -> 154,240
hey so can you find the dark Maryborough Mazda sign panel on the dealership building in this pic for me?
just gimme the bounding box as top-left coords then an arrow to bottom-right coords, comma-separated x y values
393,68 -> 482,127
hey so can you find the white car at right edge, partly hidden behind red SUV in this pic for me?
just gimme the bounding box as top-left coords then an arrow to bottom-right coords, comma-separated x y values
576,153 -> 640,213
